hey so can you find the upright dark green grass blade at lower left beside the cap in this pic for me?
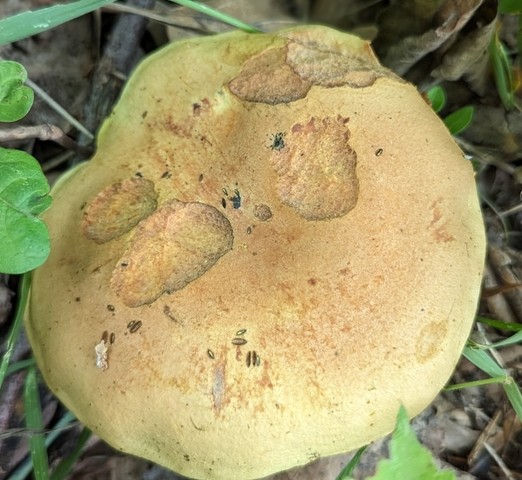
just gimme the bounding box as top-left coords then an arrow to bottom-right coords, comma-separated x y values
24,368 -> 49,480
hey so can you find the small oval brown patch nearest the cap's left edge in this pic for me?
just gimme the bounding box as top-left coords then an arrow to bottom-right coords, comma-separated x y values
82,178 -> 158,243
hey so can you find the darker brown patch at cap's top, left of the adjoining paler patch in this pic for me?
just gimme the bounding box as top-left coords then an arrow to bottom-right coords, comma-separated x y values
228,47 -> 312,105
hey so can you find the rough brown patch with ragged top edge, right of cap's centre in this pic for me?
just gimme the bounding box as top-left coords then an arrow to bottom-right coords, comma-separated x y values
272,116 -> 359,220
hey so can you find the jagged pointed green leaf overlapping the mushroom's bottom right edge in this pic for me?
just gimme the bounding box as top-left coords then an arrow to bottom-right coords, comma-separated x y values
371,406 -> 456,480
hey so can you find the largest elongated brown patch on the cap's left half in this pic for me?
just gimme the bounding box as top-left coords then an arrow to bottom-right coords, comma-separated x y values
111,200 -> 234,307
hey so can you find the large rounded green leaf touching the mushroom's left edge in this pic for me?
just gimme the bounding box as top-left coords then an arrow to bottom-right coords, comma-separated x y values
0,148 -> 51,274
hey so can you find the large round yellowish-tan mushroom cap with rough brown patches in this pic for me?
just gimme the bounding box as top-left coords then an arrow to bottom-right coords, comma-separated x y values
26,26 -> 485,480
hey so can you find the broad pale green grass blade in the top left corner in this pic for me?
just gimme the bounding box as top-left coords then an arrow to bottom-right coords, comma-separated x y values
0,0 -> 116,45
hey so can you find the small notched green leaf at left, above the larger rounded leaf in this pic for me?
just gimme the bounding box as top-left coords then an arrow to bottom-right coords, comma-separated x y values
0,60 -> 34,122
